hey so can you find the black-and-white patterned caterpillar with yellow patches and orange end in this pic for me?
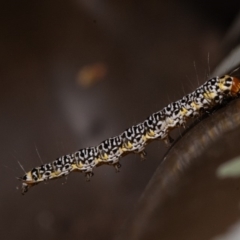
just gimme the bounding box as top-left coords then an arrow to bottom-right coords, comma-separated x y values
18,75 -> 240,195
